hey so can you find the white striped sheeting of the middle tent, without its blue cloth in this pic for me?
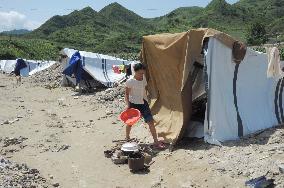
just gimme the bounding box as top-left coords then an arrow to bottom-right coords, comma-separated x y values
63,48 -> 136,87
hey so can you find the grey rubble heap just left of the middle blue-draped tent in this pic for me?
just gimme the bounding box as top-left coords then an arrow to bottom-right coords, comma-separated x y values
31,62 -> 63,89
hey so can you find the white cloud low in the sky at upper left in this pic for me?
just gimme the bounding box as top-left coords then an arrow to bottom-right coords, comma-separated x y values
0,11 -> 40,32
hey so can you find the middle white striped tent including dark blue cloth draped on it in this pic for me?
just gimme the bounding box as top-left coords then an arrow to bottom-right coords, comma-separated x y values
63,48 -> 137,87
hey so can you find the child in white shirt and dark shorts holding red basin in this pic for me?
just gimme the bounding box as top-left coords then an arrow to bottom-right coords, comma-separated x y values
125,63 -> 165,149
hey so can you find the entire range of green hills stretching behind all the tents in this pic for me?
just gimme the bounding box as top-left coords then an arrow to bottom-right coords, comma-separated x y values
0,0 -> 284,60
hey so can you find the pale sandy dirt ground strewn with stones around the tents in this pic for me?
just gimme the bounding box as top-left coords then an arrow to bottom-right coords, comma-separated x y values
0,74 -> 284,188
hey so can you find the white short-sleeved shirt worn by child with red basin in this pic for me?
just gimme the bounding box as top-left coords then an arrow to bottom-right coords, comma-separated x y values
125,76 -> 147,104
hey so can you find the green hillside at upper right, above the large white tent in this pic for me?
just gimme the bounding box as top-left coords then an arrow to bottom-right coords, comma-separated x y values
162,0 -> 284,41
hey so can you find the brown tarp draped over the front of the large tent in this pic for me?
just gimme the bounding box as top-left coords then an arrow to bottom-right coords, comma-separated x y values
141,29 -> 240,144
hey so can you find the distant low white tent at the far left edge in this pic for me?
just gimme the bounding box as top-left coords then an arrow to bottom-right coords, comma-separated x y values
0,60 -> 56,77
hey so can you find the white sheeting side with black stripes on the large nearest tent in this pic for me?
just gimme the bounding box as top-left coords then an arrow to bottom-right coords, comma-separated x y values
204,38 -> 284,144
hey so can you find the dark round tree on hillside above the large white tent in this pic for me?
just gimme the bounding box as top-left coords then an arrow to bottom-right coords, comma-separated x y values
246,22 -> 268,45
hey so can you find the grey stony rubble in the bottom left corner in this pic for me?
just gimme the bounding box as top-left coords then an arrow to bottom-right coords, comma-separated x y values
0,156 -> 52,188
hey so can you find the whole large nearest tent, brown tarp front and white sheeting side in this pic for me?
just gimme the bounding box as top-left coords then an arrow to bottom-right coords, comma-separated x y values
141,29 -> 284,145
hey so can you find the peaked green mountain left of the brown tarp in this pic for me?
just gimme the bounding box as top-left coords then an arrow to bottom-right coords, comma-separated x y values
28,3 -> 154,53
